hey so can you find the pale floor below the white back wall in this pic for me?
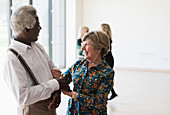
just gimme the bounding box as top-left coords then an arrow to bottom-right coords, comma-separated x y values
57,70 -> 170,115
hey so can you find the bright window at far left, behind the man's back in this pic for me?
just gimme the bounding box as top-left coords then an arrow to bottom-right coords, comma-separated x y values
0,0 -> 16,115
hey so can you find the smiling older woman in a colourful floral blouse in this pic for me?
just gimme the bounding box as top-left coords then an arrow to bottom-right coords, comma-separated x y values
52,31 -> 114,115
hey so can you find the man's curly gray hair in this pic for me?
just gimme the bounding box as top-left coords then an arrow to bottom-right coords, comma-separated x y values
10,5 -> 37,35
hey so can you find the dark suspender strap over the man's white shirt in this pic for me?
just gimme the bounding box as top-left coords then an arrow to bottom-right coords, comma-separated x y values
9,48 -> 39,85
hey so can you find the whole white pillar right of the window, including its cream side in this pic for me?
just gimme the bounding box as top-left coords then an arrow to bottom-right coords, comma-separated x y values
66,0 -> 83,68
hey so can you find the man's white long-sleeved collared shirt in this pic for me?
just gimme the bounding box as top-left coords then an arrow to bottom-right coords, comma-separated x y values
3,39 -> 59,109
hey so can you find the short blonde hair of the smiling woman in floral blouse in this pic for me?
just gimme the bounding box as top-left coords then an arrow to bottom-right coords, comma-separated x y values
82,31 -> 110,58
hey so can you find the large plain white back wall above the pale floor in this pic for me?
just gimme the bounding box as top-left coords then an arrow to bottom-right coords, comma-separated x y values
76,0 -> 170,71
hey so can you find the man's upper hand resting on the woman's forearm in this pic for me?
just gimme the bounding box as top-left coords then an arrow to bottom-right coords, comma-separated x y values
56,77 -> 72,92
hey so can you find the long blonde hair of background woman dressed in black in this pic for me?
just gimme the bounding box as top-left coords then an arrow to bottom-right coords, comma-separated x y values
101,23 -> 112,42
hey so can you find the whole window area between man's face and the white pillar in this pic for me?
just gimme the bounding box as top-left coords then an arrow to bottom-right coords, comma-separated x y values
33,0 -> 66,68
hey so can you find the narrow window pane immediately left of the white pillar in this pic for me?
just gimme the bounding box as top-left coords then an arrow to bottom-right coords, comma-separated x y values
52,0 -> 66,68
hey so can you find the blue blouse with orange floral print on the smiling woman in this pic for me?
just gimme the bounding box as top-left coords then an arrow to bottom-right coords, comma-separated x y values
62,59 -> 114,115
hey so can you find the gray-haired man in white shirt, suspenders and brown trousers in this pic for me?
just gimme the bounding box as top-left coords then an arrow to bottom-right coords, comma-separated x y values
3,5 -> 69,115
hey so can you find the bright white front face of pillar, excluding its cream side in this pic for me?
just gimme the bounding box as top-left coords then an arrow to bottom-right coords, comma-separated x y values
66,0 -> 76,67
